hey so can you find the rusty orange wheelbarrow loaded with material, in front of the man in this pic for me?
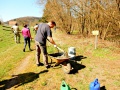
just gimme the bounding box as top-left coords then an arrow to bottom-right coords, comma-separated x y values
48,47 -> 73,74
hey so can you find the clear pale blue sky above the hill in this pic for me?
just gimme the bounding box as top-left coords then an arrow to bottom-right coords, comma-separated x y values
0,0 -> 44,22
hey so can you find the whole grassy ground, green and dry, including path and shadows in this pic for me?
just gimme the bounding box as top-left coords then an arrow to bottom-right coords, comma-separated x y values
0,26 -> 120,90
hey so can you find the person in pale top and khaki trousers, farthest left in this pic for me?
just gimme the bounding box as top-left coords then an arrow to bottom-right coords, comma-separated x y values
12,23 -> 20,43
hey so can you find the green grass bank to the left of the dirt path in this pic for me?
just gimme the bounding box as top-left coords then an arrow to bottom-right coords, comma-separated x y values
0,25 -> 33,78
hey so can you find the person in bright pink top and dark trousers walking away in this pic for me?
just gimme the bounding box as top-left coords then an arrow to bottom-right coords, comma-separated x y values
22,24 -> 32,52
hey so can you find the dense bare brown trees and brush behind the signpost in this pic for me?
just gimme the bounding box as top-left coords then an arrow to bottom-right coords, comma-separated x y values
38,0 -> 120,40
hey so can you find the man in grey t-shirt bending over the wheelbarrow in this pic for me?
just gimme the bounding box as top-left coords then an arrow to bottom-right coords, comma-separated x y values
35,21 -> 57,69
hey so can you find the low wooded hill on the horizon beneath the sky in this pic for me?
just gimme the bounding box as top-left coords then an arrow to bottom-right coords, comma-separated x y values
4,16 -> 41,25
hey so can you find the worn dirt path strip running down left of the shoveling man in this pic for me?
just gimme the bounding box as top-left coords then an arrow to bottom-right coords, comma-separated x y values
5,52 -> 34,90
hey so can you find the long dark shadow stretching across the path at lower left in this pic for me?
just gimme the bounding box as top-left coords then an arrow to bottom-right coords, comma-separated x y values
0,70 -> 48,90
